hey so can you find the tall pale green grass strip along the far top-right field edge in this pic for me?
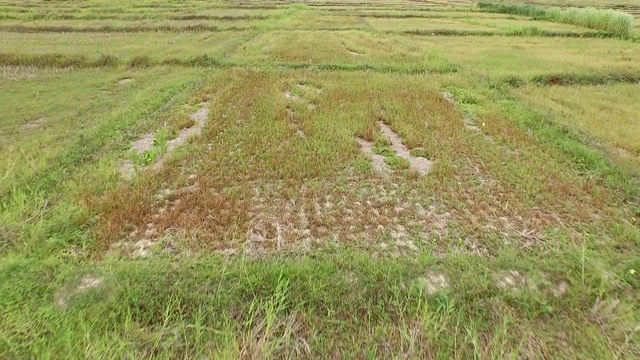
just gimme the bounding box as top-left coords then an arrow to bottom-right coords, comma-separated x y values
478,2 -> 633,36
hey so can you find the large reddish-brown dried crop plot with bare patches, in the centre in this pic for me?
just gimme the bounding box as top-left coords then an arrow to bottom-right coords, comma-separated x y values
87,69 -> 628,255
